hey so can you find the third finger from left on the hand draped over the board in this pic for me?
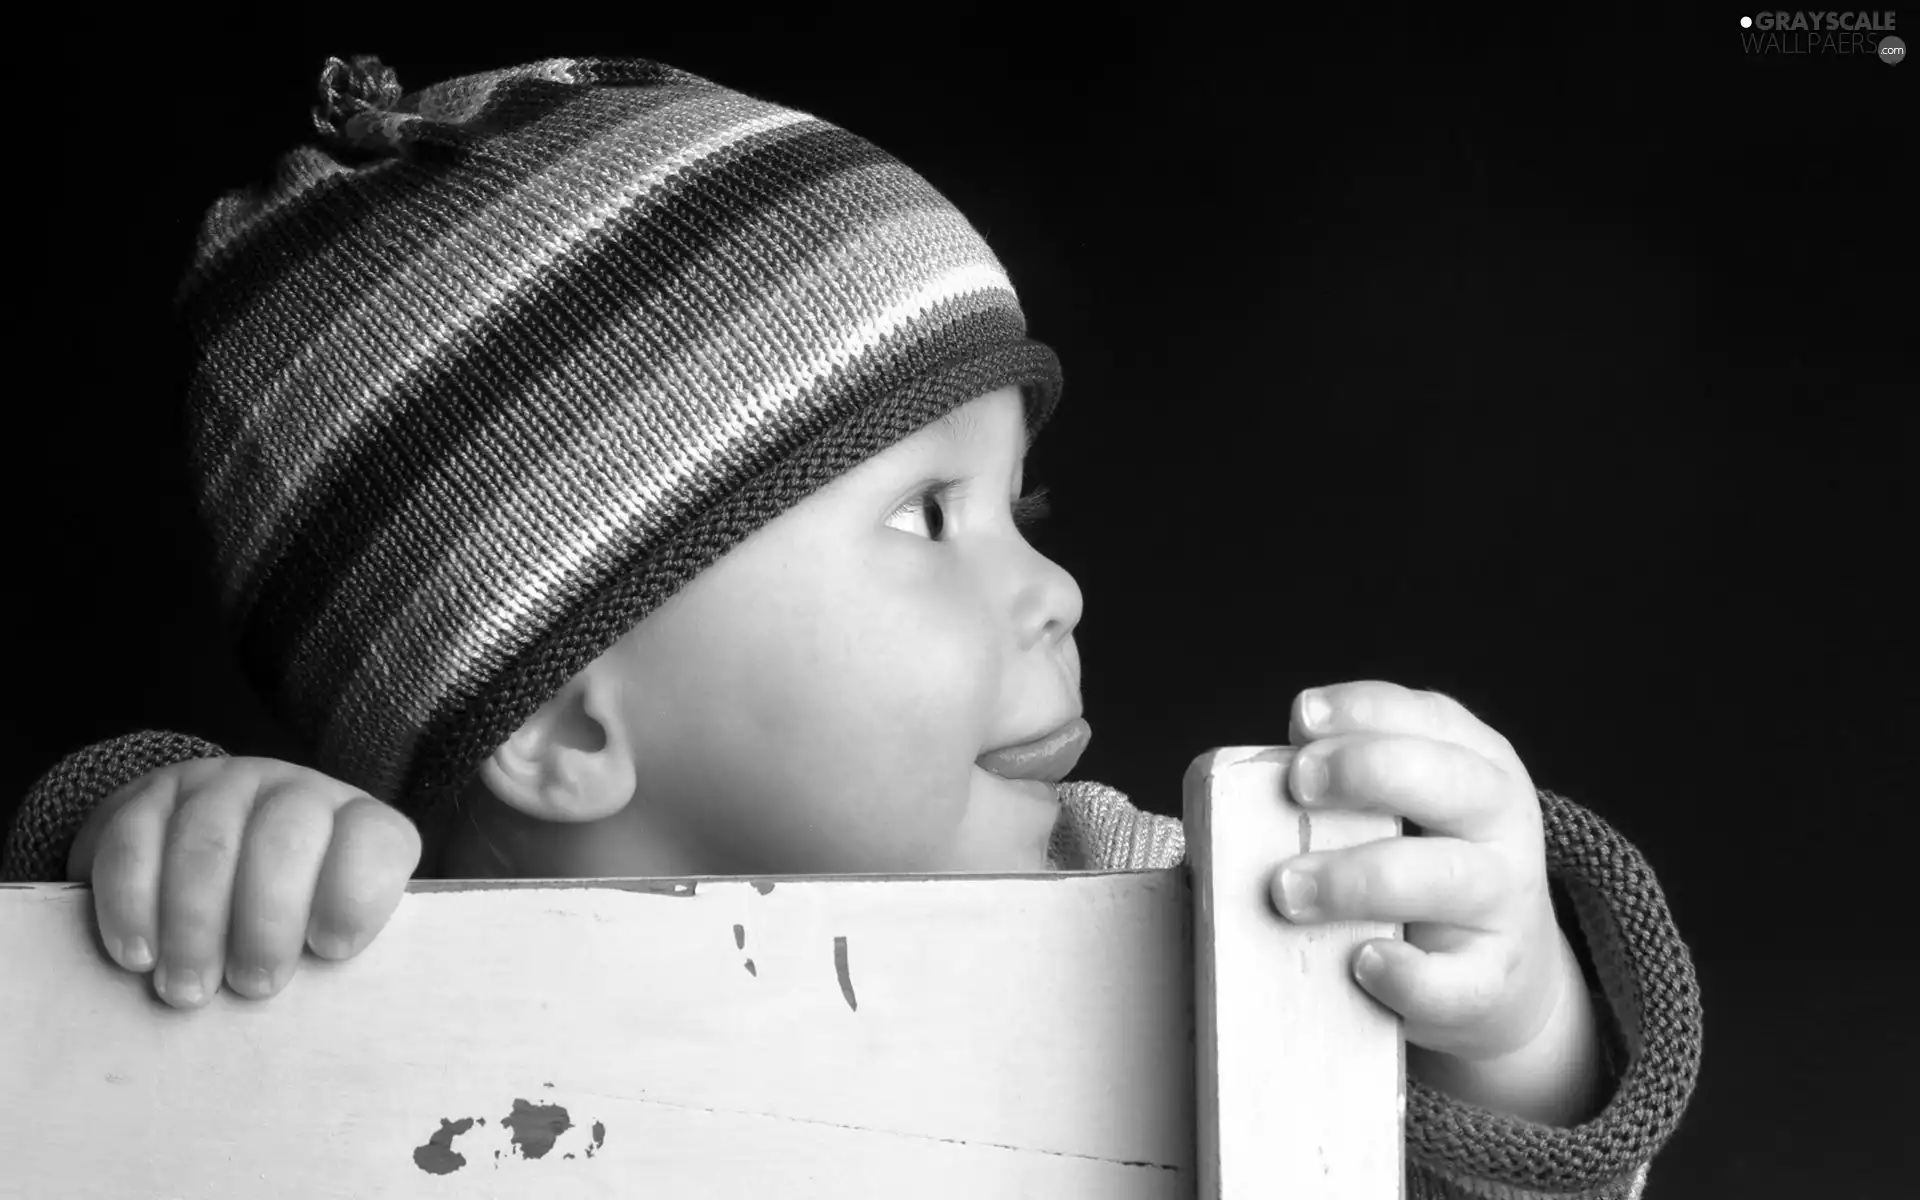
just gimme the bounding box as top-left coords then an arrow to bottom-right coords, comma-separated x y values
227,783 -> 340,998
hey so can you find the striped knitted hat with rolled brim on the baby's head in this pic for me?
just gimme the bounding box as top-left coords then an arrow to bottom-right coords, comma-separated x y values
179,58 -> 1060,816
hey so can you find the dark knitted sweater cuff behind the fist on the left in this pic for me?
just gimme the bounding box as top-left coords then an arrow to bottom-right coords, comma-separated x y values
0,732 -> 227,883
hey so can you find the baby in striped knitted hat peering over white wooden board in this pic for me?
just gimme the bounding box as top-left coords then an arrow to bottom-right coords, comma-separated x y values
4,58 -> 1699,1196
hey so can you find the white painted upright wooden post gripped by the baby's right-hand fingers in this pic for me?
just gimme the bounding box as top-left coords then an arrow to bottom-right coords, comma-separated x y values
1183,747 -> 1405,1200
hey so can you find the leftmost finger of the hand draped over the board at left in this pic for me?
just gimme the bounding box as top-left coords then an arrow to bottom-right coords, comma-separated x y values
88,772 -> 180,972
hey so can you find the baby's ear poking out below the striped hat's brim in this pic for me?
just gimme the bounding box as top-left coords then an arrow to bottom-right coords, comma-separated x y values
480,659 -> 636,824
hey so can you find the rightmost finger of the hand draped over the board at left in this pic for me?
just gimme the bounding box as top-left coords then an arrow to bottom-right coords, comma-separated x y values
307,797 -> 420,960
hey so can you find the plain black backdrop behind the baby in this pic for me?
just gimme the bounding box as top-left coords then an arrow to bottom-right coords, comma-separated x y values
18,8 -> 1920,1200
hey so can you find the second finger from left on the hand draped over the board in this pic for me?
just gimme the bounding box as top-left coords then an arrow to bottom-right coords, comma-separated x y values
154,770 -> 259,1008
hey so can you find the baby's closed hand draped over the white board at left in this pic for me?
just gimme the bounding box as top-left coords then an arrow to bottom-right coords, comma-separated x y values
67,758 -> 420,1008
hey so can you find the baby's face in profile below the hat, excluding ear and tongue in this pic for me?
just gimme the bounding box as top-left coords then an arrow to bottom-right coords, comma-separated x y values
564,388 -> 1081,874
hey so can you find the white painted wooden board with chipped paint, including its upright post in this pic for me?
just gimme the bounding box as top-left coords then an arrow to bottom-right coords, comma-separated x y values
0,749 -> 1400,1198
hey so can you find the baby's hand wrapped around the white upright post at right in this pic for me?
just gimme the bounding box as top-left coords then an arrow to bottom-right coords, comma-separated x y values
1273,682 -> 1571,1062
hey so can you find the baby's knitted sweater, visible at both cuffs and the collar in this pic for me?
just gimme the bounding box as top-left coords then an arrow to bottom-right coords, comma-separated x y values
0,733 -> 1701,1200
